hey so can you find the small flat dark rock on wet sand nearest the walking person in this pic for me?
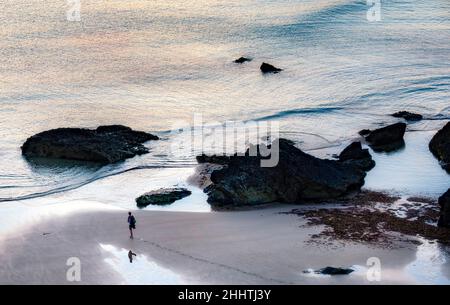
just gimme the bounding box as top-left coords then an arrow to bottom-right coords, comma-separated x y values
136,188 -> 191,208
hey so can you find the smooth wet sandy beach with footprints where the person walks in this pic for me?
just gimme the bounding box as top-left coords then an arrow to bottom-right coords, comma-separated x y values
0,200 -> 450,284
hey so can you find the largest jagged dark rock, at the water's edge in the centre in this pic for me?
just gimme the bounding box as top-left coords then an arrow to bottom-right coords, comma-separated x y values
201,139 -> 366,207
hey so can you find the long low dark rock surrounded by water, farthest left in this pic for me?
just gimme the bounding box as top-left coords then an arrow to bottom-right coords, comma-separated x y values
22,125 -> 158,164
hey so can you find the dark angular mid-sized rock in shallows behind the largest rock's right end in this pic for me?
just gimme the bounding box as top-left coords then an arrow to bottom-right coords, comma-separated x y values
366,123 -> 406,152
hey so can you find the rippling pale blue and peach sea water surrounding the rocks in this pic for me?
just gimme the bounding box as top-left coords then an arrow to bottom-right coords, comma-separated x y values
0,0 -> 450,210
